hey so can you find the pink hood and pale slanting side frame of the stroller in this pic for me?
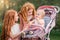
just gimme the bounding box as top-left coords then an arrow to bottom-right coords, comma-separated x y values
37,5 -> 60,40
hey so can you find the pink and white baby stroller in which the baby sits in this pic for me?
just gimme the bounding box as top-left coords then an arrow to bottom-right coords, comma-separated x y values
22,5 -> 60,40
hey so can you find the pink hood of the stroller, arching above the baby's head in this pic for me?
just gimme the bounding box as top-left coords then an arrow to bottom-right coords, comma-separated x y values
37,5 -> 60,13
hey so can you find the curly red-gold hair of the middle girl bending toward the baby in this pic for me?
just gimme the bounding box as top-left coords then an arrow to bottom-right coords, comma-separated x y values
19,2 -> 36,29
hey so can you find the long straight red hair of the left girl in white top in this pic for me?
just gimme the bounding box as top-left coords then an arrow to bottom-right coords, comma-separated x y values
1,10 -> 17,40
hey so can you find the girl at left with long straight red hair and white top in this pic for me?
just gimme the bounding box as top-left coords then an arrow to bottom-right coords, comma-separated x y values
1,9 -> 20,40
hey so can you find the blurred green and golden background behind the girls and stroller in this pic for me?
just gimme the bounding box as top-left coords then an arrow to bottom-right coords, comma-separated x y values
0,0 -> 60,40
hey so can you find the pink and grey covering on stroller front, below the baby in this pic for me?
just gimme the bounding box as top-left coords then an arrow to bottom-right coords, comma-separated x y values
22,25 -> 44,38
